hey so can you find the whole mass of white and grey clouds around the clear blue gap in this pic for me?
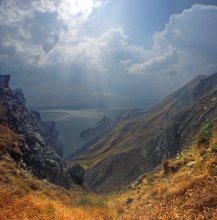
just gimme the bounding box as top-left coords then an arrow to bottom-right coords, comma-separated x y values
0,0 -> 217,107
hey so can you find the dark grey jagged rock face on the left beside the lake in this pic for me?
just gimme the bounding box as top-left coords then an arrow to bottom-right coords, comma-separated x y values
0,77 -> 84,187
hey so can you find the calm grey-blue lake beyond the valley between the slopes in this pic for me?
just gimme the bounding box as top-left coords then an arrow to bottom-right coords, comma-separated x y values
37,108 -> 126,157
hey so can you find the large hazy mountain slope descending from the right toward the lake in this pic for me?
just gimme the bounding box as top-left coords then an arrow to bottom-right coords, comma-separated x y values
72,73 -> 217,192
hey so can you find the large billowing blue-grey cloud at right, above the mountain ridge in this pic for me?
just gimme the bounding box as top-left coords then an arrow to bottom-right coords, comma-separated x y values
127,5 -> 217,78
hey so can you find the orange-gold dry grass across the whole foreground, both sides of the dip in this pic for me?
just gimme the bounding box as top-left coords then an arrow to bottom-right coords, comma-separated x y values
0,126 -> 217,220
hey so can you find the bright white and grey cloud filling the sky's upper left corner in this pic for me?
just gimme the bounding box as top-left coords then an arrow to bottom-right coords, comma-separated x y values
0,0 -> 105,65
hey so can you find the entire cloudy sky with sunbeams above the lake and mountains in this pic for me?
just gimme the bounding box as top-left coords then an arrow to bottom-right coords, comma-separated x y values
0,0 -> 217,108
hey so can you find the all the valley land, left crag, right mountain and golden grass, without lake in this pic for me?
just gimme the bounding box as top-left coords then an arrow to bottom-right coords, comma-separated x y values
0,74 -> 217,220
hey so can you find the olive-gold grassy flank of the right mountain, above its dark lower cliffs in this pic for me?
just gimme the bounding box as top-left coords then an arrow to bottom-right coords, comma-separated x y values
71,76 -> 214,170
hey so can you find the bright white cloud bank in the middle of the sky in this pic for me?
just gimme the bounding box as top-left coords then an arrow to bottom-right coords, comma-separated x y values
45,27 -> 150,72
